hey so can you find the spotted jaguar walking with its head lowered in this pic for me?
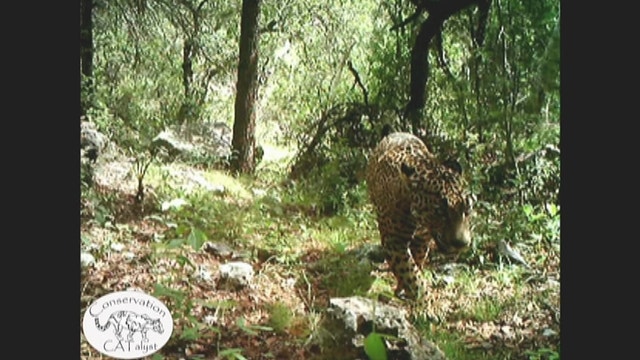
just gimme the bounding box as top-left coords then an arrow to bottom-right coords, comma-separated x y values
365,132 -> 472,299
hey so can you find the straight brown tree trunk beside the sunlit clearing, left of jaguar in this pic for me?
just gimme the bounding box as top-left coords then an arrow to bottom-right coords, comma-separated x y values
231,0 -> 260,174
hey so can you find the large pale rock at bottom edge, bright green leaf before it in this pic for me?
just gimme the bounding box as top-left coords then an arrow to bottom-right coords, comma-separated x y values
324,296 -> 446,360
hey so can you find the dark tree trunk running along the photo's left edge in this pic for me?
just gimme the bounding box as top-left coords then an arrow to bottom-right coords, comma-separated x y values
80,0 -> 93,116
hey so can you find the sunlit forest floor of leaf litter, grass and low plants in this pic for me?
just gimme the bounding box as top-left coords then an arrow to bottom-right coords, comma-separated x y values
80,146 -> 560,360
